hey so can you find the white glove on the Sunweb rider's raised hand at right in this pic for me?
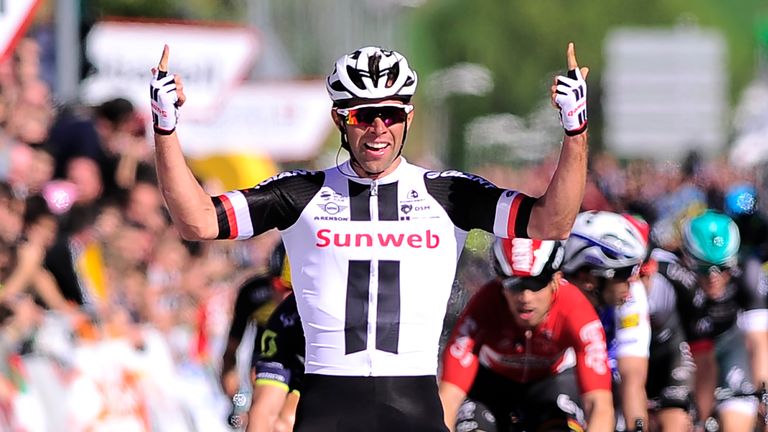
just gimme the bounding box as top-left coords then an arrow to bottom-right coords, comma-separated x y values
555,68 -> 587,136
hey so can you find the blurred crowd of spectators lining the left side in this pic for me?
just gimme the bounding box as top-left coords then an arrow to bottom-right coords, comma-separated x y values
0,39 -> 278,430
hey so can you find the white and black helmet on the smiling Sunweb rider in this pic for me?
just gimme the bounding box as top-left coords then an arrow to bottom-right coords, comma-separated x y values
325,47 -> 417,107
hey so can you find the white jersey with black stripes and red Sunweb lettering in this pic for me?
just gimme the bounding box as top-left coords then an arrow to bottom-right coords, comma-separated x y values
213,159 -> 536,376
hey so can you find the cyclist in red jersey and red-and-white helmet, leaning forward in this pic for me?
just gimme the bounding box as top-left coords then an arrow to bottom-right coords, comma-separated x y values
440,238 -> 615,432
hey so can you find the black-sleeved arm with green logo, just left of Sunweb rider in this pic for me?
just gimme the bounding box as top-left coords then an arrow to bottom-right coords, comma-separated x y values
248,294 -> 304,432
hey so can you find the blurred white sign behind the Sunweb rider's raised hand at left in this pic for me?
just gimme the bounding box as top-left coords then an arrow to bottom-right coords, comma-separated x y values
80,20 -> 259,119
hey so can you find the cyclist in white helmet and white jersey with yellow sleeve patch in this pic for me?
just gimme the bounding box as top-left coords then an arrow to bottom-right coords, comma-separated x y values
563,211 -> 651,430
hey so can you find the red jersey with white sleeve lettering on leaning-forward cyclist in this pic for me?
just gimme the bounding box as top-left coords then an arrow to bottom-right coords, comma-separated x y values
442,280 -> 611,394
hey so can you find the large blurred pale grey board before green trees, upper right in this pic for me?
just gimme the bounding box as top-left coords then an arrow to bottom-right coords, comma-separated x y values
602,26 -> 728,160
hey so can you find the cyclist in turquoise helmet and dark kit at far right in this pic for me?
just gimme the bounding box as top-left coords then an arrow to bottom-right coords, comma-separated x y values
673,210 -> 768,432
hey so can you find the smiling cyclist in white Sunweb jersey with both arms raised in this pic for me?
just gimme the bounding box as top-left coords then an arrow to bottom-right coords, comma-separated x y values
151,45 -> 587,432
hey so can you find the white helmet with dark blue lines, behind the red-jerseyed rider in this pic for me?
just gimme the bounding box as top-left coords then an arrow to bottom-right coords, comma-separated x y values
563,211 -> 648,278
